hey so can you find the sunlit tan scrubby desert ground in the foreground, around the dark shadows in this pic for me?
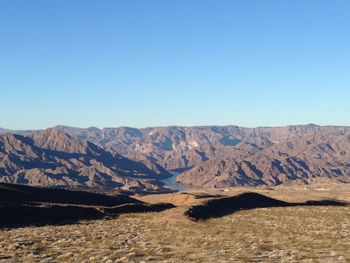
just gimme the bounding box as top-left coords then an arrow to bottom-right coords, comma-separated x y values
0,188 -> 350,263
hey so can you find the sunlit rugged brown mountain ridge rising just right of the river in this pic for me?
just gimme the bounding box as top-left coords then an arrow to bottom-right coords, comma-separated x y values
178,133 -> 350,187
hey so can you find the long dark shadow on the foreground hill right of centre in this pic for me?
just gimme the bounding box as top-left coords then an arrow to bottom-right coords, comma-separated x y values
185,193 -> 348,221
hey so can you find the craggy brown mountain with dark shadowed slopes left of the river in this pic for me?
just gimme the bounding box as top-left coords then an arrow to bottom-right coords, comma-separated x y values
0,129 -> 170,191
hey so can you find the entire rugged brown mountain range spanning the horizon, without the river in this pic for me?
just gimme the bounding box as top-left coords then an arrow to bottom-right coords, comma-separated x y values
0,124 -> 350,190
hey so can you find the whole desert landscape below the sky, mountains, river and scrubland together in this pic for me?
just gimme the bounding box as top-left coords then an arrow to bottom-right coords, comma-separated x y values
0,125 -> 350,263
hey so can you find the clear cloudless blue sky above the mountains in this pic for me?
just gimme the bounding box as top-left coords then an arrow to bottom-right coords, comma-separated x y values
0,0 -> 350,129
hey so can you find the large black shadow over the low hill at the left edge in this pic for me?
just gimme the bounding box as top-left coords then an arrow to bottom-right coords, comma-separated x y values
0,184 -> 175,228
